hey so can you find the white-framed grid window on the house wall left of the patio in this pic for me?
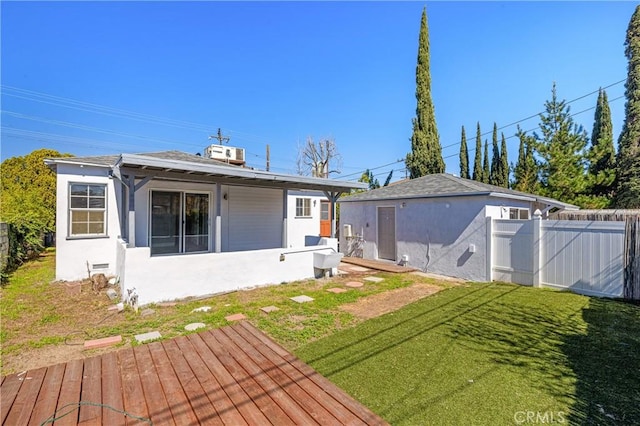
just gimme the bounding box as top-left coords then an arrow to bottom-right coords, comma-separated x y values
69,183 -> 107,237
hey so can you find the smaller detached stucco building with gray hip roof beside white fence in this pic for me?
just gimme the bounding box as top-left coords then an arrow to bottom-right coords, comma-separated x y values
338,174 -> 578,281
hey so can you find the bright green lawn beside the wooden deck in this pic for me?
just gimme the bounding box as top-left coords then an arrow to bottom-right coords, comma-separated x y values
296,284 -> 640,425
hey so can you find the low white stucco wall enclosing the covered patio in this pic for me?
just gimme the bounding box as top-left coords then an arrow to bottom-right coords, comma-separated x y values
118,239 -> 337,305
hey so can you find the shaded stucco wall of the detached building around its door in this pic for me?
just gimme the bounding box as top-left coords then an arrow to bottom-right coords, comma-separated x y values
340,196 -> 531,281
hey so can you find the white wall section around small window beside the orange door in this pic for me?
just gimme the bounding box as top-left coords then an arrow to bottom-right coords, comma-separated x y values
287,191 -> 327,247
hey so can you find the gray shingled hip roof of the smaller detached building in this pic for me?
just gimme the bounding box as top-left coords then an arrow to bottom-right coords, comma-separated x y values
339,173 -> 578,210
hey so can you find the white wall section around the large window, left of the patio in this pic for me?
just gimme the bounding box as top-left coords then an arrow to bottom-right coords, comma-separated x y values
56,164 -> 120,280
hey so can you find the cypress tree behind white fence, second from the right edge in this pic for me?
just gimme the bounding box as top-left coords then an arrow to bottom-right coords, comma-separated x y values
589,89 -> 616,201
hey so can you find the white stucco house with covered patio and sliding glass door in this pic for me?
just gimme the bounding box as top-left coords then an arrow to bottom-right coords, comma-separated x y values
46,151 -> 365,305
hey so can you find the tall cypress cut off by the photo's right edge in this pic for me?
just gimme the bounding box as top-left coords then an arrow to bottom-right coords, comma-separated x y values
615,6 -> 640,209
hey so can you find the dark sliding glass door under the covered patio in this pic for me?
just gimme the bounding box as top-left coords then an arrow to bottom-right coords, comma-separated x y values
150,191 -> 209,254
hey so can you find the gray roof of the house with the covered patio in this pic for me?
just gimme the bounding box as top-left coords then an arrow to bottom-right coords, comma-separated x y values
45,151 -> 367,192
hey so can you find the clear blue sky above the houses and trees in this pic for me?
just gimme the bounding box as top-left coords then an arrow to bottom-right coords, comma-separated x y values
0,1 -> 637,180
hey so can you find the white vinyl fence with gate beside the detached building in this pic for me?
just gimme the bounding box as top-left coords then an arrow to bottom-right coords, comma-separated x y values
487,216 -> 625,297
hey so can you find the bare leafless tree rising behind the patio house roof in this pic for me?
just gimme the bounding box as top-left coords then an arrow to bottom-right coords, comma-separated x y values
296,136 -> 342,178
